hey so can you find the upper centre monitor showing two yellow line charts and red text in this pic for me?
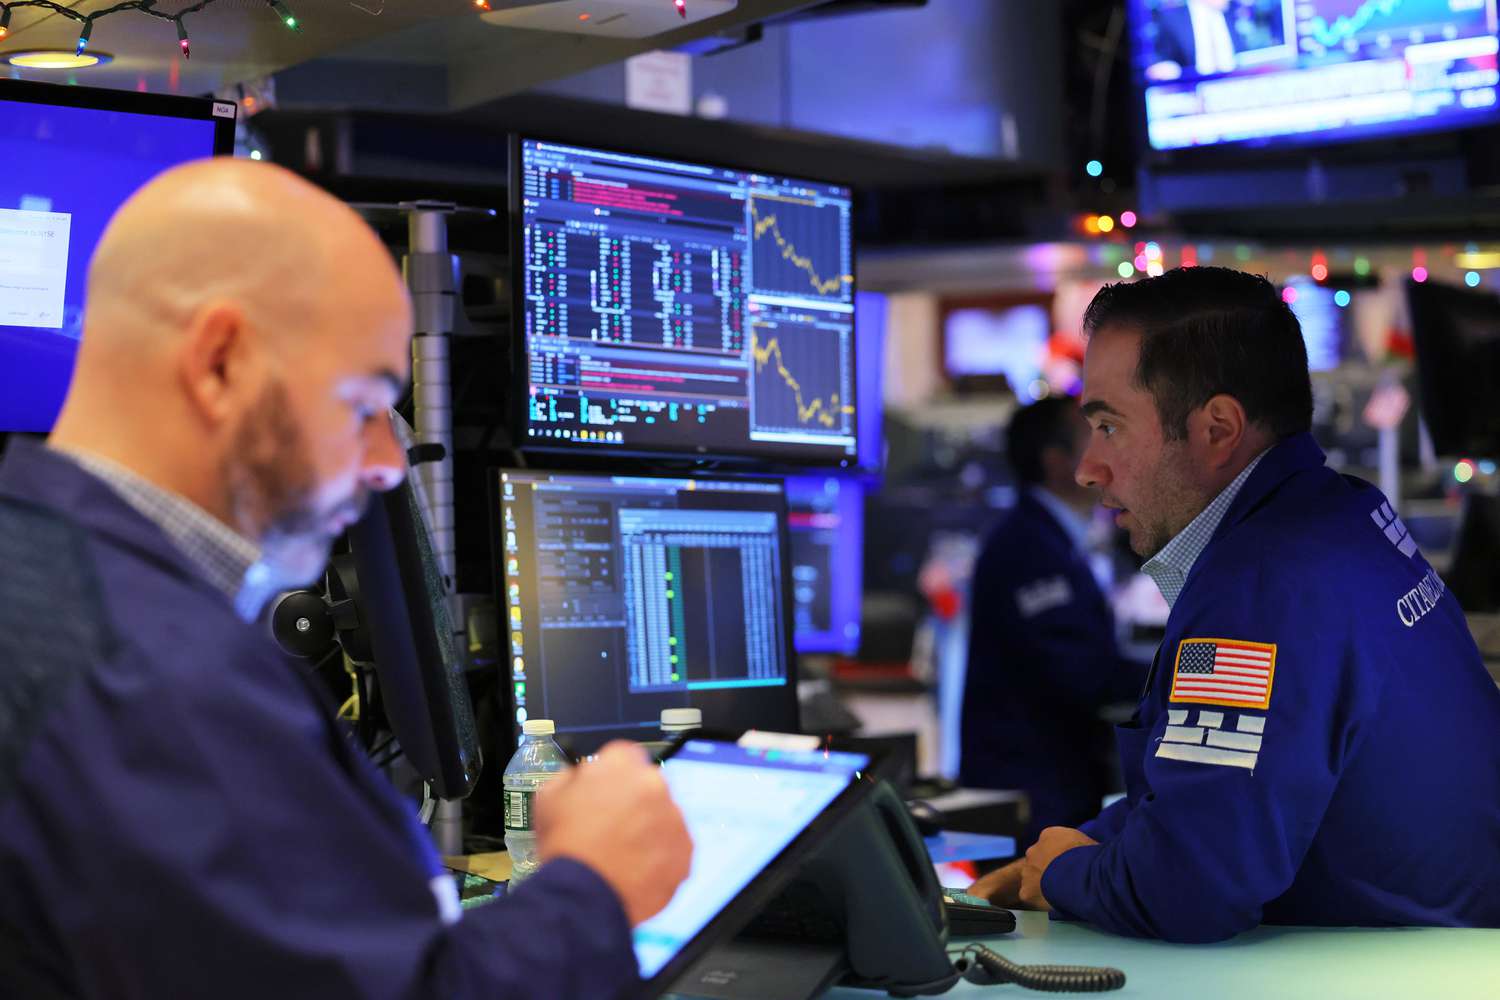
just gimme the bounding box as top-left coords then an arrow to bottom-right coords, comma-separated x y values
510,138 -> 858,466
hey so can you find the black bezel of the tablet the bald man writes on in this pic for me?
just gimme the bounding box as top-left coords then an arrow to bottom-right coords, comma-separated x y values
632,730 -> 882,997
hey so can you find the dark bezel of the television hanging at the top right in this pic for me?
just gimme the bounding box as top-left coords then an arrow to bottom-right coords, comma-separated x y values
1125,0 -> 1500,160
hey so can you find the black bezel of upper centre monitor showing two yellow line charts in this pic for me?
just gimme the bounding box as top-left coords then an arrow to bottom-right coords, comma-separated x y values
507,132 -> 860,472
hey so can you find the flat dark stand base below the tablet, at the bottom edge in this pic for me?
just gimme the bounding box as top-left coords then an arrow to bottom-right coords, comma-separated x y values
665,939 -> 845,1000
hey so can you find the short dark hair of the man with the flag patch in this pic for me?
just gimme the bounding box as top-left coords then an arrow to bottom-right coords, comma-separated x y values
1083,267 -> 1313,441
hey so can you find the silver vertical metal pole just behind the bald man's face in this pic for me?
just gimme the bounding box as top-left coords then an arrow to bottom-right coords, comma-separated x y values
402,202 -> 464,855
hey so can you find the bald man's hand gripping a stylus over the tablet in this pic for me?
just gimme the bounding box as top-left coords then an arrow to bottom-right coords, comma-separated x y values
537,742 -> 693,927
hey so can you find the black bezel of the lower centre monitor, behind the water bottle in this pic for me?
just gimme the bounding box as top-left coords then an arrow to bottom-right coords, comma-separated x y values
488,465 -> 803,747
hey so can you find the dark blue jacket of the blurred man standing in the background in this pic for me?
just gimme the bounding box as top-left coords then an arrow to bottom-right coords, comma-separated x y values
959,490 -> 1146,844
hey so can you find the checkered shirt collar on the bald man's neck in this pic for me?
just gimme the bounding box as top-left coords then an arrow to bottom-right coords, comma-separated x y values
57,448 -> 261,603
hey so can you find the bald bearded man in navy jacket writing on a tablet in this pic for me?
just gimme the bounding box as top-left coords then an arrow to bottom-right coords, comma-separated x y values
0,160 -> 692,999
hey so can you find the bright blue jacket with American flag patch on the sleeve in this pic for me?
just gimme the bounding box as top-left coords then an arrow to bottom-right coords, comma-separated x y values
1041,435 -> 1500,942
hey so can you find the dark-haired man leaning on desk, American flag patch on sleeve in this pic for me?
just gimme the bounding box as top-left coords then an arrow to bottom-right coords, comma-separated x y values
977,268 -> 1500,942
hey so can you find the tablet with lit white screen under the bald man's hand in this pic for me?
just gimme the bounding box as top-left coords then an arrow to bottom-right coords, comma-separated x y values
635,738 -> 875,996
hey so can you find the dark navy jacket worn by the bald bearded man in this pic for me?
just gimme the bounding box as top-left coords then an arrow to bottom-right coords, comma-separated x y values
0,441 -> 639,1000
